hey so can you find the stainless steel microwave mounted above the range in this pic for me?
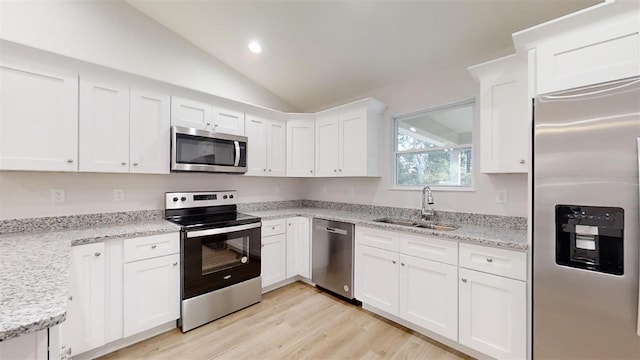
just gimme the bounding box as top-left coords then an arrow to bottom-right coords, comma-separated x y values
171,126 -> 247,174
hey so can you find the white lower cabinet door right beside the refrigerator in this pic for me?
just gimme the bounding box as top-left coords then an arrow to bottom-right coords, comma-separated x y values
459,268 -> 524,359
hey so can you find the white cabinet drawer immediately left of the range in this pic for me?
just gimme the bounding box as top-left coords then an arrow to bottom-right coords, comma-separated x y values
123,233 -> 180,263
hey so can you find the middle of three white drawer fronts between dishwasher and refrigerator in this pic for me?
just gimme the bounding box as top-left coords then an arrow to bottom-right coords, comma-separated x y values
400,234 -> 458,265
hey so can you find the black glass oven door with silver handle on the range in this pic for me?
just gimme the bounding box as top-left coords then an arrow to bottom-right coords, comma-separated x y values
182,223 -> 261,300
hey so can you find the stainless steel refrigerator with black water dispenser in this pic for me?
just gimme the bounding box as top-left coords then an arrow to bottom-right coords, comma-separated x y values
532,78 -> 640,359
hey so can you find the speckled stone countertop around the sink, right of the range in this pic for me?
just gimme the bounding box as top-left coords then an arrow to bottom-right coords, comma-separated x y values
245,208 -> 529,251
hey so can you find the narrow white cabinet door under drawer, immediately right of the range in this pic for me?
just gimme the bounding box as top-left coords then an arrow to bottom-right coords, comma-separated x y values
260,234 -> 287,288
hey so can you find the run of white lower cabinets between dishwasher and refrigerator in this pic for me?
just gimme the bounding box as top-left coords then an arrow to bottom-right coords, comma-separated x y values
355,227 -> 527,359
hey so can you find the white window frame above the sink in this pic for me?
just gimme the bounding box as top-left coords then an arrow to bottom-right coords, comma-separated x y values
389,97 -> 478,192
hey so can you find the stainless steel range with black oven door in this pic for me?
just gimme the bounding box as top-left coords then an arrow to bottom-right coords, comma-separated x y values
165,191 -> 262,332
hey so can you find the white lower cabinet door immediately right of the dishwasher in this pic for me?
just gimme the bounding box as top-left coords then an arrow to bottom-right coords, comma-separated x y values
355,244 -> 400,316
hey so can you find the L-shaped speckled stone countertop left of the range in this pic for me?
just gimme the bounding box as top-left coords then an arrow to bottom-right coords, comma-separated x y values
0,220 -> 180,341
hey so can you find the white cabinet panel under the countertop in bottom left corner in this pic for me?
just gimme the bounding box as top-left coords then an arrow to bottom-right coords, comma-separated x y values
0,329 -> 48,360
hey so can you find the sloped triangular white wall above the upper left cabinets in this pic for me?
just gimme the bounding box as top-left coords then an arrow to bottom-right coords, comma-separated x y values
0,1 -> 297,111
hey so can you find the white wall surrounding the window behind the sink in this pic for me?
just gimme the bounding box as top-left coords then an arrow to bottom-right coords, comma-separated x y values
304,59 -> 527,216
